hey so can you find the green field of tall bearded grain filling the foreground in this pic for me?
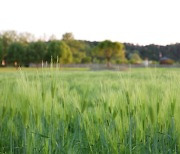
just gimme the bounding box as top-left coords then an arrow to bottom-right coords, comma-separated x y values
0,68 -> 180,154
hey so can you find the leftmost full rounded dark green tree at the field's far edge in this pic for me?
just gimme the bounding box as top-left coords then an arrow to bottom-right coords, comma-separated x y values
6,42 -> 25,65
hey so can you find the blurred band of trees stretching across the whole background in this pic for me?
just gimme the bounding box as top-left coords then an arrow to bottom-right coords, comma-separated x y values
0,31 -> 180,66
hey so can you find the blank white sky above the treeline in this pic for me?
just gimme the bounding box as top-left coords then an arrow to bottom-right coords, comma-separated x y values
0,0 -> 180,45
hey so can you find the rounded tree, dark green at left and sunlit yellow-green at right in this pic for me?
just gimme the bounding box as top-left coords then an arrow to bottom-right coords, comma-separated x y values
47,40 -> 72,64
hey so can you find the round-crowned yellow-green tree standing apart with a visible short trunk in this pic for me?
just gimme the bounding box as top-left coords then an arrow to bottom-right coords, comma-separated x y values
95,40 -> 125,67
